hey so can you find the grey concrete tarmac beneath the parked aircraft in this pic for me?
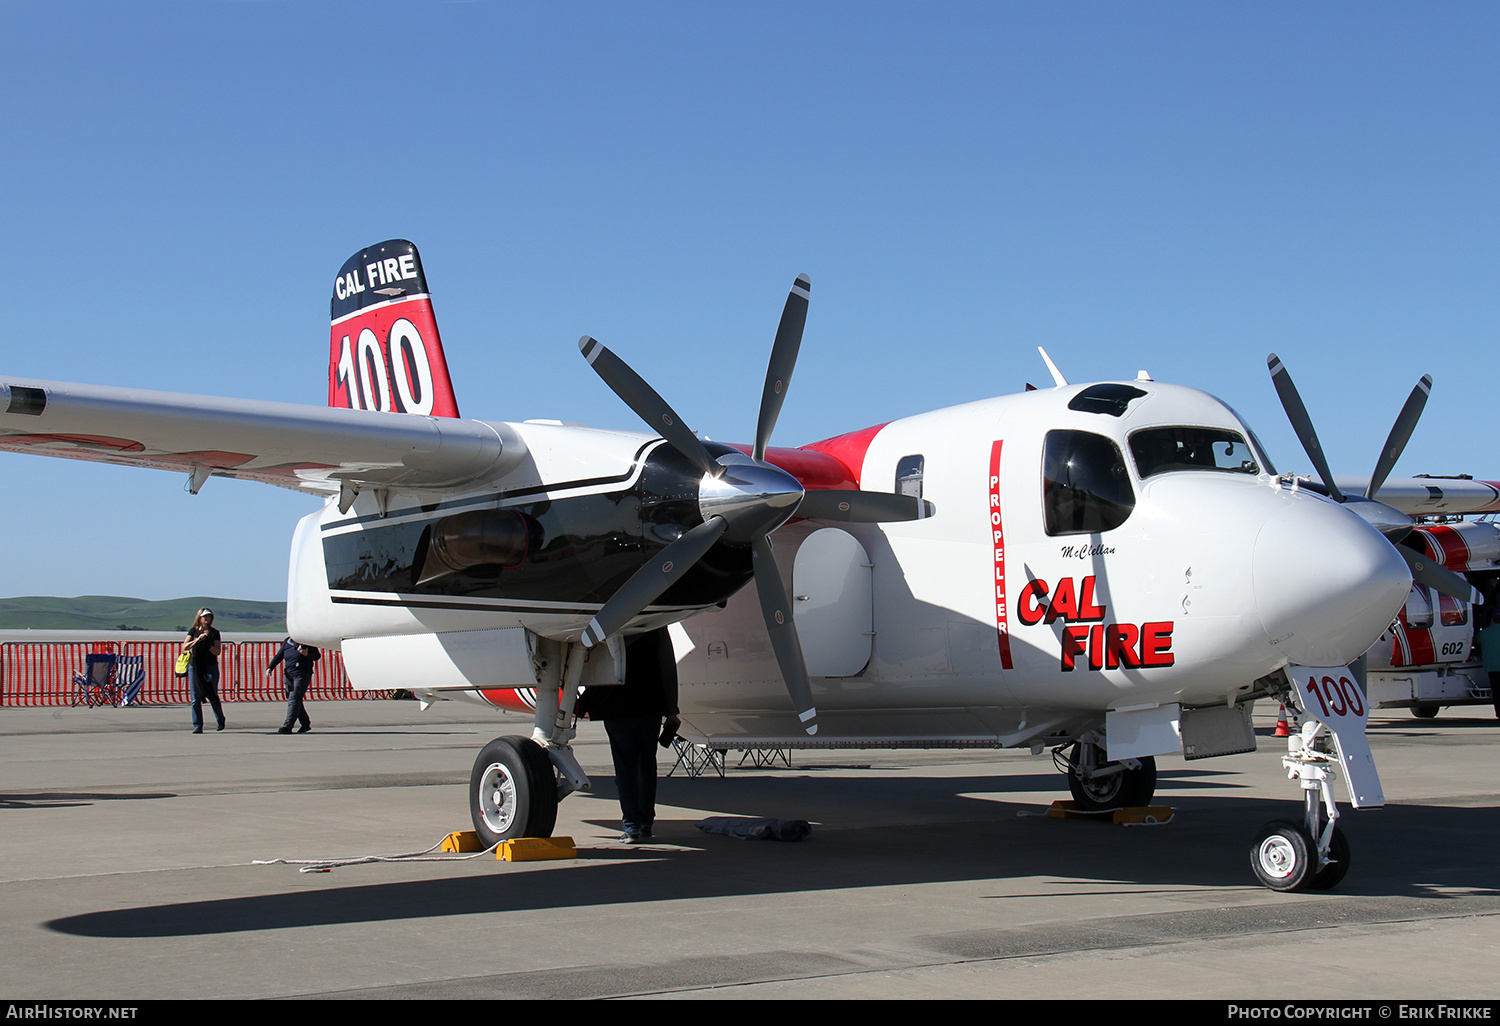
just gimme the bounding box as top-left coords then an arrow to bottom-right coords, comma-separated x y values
0,702 -> 1500,1001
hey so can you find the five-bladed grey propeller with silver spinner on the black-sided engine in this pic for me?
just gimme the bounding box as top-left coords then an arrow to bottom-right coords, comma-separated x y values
579,275 -> 906,734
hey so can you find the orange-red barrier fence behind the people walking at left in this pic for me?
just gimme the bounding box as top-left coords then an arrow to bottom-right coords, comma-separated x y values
0,641 -> 390,705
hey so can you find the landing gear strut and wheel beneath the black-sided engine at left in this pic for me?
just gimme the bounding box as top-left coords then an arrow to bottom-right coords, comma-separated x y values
470,638 -> 590,848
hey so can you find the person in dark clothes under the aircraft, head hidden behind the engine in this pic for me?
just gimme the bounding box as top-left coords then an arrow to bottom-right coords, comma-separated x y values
579,629 -> 683,845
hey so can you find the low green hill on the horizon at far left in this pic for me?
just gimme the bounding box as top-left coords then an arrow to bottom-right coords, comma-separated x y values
0,596 -> 287,635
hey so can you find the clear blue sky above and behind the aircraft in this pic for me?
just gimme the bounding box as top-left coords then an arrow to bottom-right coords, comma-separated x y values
0,0 -> 1500,599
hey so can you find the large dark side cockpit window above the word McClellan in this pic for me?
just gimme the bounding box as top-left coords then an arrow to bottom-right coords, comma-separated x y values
1041,431 -> 1136,534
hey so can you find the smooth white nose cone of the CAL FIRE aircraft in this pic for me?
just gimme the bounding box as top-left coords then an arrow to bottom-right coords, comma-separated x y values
1251,495 -> 1412,666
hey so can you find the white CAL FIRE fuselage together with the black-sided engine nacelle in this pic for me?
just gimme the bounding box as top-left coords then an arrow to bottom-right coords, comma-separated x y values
288,381 -> 1410,743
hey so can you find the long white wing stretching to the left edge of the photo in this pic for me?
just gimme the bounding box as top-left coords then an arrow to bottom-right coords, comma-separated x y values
0,377 -> 525,495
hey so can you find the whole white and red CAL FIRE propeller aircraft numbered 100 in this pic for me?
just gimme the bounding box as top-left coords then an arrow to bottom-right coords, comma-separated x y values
0,240 -> 1470,890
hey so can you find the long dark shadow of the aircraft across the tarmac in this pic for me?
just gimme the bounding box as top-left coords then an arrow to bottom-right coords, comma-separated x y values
45,776 -> 1500,938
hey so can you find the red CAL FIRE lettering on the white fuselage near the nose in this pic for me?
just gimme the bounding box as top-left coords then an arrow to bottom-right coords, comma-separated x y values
1016,575 -> 1176,671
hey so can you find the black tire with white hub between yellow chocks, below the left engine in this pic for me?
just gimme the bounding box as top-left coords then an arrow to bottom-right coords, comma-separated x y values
470,737 -> 558,848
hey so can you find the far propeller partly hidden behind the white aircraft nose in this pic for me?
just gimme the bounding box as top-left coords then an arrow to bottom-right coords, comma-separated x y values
1266,353 -> 1481,603
